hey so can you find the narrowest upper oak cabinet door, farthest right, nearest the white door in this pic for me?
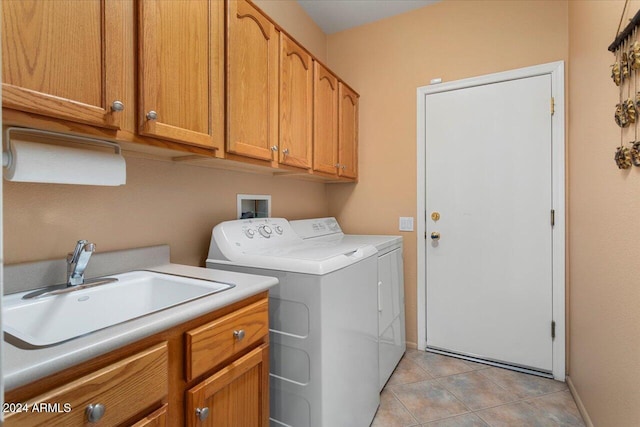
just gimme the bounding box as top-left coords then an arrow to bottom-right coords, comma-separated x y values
338,82 -> 358,179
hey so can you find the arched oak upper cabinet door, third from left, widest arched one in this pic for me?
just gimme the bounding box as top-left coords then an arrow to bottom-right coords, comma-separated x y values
227,0 -> 278,160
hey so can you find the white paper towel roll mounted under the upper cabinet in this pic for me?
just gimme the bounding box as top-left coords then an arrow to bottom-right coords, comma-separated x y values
4,139 -> 127,186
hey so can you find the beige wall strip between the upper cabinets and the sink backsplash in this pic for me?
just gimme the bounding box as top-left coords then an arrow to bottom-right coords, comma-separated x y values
3,157 -> 328,266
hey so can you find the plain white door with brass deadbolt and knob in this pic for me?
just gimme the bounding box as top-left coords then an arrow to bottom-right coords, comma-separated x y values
425,75 -> 553,372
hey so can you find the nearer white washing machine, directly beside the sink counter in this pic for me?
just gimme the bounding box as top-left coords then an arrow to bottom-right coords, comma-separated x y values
207,218 -> 380,427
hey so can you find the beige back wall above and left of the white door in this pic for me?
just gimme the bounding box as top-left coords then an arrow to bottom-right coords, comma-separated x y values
328,1 -> 568,352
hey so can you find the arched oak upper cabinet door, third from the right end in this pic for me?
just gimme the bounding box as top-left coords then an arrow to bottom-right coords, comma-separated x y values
279,33 -> 313,169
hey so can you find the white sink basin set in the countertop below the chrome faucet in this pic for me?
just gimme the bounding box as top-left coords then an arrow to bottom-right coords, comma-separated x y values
2,271 -> 234,347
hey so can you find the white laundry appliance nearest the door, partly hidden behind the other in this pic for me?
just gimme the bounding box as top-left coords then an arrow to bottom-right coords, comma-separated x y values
289,217 -> 407,390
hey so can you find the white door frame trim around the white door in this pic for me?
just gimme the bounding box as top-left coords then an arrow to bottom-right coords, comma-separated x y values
416,61 -> 566,381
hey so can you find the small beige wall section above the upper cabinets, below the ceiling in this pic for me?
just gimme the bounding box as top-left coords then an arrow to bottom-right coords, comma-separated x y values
253,0 -> 327,63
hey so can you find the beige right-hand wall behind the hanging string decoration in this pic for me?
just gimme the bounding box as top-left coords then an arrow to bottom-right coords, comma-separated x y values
569,0 -> 640,427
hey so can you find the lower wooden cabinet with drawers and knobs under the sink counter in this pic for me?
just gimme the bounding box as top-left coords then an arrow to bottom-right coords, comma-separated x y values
4,291 -> 269,427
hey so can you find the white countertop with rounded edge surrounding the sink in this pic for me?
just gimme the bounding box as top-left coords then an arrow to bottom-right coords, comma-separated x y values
2,264 -> 278,390
